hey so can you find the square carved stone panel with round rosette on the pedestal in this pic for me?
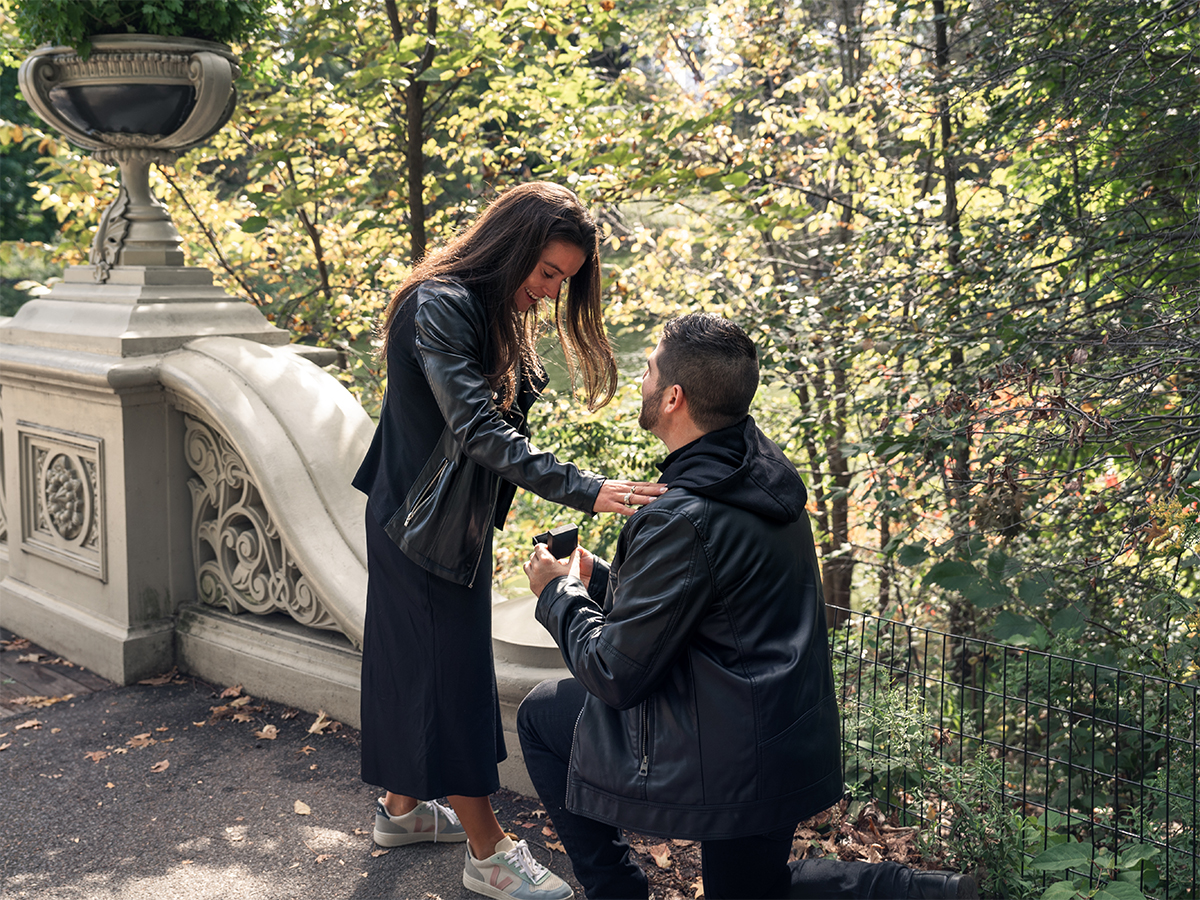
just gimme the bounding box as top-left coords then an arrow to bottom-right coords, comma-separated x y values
17,422 -> 106,581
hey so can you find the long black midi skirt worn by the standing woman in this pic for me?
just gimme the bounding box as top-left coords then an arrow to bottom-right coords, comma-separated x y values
361,510 -> 508,800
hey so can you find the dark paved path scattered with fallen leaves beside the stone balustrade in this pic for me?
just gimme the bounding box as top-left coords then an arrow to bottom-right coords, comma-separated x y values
0,631 -> 582,900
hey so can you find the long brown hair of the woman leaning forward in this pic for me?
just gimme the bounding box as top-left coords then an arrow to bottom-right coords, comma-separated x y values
379,181 -> 617,409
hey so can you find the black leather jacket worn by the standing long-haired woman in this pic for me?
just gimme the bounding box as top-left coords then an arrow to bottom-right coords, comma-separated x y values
354,281 -> 604,584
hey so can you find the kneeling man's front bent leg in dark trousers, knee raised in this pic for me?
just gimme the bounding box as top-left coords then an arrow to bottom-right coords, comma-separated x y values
517,678 -> 649,900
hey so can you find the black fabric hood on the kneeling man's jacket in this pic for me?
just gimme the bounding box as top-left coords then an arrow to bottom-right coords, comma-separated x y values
659,416 -> 809,523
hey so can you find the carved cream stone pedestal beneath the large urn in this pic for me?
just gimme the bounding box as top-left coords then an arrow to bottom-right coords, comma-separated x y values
0,266 -> 288,683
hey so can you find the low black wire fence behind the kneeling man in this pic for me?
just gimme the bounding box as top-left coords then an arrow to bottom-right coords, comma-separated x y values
832,610 -> 1200,900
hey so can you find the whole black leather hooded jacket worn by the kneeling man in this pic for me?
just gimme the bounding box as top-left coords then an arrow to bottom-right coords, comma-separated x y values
536,419 -> 842,840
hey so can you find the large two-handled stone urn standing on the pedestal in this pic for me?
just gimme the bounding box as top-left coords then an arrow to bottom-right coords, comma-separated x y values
18,35 -> 240,282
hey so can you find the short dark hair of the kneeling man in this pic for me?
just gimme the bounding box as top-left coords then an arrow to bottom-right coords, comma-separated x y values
658,312 -> 758,432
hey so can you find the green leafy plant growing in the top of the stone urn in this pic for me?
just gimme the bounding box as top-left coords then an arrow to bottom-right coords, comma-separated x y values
13,0 -> 278,59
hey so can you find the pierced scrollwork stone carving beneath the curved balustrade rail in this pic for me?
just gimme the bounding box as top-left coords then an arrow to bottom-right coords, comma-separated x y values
184,416 -> 341,631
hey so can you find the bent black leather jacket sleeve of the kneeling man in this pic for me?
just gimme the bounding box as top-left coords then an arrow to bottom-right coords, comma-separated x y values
536,510 -> 713,709
